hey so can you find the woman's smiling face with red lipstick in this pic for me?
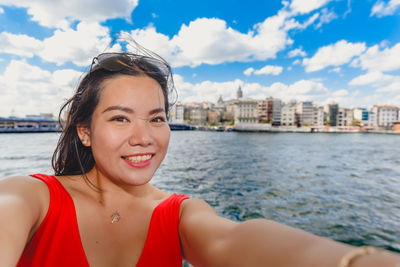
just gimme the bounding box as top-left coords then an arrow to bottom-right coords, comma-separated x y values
83,75 -> 170,185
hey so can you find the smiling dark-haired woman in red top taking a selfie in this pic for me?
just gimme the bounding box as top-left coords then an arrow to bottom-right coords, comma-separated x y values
0,47 -> 400,267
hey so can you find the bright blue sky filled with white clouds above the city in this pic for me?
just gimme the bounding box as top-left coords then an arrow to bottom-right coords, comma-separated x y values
0,0 -> 400,117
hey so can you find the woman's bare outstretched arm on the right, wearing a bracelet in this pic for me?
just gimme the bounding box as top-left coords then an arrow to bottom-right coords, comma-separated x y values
180,199 -> 400,267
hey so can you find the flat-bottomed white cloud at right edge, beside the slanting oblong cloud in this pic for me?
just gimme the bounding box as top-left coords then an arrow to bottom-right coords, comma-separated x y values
351,43 -> 400,71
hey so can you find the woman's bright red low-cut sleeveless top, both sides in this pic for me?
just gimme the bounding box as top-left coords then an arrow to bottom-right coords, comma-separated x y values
17,174 -> 188,267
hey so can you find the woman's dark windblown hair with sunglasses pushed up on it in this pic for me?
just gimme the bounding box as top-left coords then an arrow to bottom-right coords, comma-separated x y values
52,50 -> 175,179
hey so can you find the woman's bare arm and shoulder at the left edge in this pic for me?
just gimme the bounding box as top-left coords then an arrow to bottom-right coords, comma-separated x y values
0,176 -> 49,266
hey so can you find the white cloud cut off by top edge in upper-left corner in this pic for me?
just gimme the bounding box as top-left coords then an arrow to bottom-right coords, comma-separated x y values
0,0 -> 138,28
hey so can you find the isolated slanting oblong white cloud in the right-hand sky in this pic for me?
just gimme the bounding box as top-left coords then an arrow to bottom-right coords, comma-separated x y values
303,40 -> 366,72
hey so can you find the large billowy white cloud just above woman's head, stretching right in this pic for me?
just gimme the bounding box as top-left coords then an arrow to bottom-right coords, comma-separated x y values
125,12 -> 300,67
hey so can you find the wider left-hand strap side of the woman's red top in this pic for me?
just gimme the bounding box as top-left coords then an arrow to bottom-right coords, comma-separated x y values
17,174 -> 89,267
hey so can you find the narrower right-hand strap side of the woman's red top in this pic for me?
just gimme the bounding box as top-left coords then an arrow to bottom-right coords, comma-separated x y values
136,194 -> 188,267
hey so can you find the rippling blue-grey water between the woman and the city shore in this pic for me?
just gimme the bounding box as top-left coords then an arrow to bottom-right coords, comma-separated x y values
0,131 -> 400,252
